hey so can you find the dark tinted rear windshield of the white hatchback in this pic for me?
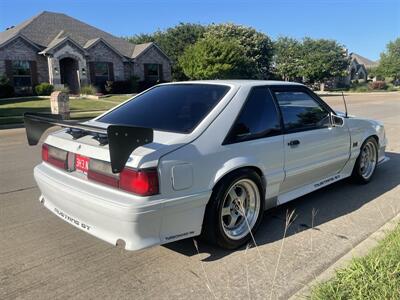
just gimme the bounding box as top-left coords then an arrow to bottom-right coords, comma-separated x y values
98,84 -> 229,133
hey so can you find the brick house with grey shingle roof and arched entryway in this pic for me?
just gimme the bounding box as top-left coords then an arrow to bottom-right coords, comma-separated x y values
0,11 -> 171,93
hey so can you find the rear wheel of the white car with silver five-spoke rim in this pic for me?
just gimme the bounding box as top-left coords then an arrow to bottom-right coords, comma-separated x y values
202,168 -> 264,250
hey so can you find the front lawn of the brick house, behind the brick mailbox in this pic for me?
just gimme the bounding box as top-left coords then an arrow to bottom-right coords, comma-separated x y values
0,95 -> 129,124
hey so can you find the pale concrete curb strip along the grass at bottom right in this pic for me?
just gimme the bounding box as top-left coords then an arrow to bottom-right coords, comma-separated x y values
289,214 -> 400,300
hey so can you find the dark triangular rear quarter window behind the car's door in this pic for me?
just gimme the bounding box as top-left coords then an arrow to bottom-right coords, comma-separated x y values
226,87 -> 281,143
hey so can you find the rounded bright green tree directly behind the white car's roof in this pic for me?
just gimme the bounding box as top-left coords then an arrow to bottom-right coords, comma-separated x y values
179,36 -> 251,79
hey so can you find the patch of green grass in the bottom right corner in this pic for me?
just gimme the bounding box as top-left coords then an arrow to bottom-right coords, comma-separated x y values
310,224 -> 400,300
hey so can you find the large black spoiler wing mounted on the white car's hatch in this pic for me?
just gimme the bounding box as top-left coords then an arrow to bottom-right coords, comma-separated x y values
24,113 -> 154,173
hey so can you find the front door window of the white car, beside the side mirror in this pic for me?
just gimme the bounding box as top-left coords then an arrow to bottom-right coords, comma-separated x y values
275,91 -> 330,132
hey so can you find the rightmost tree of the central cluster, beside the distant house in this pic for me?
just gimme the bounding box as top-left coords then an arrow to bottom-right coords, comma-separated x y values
301,38 -> 350,88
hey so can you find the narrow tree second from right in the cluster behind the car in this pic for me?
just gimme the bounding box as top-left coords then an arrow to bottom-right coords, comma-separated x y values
274,37 -> 303,81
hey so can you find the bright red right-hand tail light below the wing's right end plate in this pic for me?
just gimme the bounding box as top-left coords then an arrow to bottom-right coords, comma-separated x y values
119,168 -> 158,196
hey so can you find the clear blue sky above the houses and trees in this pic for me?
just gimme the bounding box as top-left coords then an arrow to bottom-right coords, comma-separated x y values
0,0 -> 400,60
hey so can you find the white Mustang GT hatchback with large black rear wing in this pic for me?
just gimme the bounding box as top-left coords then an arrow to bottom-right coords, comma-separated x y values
25,80 -> 386,250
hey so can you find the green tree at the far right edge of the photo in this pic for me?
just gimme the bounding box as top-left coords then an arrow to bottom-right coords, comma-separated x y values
376,38 -> 400,79
